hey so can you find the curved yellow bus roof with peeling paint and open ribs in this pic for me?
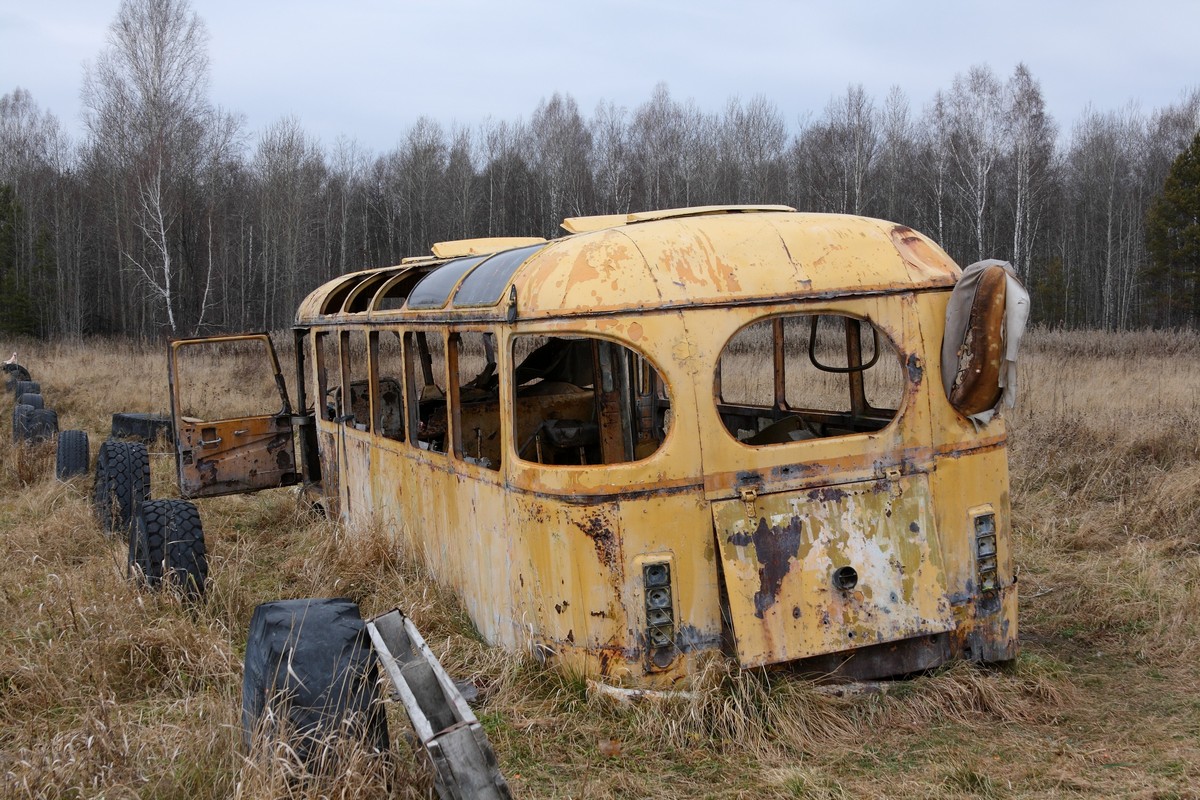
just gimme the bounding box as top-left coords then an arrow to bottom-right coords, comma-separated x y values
296,206 -> 960,325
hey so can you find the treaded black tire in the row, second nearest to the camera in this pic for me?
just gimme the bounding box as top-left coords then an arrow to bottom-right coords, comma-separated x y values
130,500 -> 209,600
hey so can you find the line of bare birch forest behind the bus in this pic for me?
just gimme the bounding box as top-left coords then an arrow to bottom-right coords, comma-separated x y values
0,0 -> 1200,337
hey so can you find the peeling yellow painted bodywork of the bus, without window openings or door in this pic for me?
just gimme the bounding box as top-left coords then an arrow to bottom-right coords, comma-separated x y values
182,209 -> 1016,686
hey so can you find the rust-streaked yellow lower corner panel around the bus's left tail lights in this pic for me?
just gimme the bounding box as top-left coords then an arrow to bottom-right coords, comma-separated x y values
501,488 -> 721,686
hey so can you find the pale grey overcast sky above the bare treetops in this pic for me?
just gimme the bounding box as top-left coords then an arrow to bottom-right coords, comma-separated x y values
0,0 -> 1200,152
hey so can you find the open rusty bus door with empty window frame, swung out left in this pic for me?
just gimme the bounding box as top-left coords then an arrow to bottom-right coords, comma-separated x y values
167,333 -> 300,498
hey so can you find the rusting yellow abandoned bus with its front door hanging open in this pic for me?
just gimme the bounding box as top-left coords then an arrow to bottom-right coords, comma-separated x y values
170,206 -> 1016,687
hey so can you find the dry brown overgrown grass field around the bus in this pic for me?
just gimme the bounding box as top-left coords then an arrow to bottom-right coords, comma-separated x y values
0,331 -> 1200,800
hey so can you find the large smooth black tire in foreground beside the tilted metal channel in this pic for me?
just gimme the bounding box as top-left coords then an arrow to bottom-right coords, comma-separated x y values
241,597 -> 388,768
